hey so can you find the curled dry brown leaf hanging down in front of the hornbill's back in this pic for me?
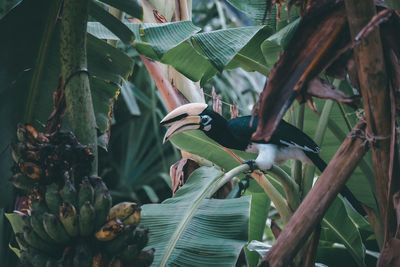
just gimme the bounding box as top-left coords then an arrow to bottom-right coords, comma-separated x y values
253,1 -> 348,141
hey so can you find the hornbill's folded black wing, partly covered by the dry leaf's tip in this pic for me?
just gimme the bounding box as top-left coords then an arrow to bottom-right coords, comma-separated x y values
228,116 -> 320,153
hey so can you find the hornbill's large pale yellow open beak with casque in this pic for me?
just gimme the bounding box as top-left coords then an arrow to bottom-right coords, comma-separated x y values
160,103 -> 207,143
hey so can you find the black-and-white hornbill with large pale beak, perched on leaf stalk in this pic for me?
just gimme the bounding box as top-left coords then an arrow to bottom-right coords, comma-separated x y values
160,103 -> 365,215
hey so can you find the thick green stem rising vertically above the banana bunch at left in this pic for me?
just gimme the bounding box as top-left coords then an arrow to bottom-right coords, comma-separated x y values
60,0 -> 97,173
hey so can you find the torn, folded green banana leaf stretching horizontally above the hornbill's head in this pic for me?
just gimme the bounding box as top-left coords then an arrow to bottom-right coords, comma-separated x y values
88,21 -> 272,85
